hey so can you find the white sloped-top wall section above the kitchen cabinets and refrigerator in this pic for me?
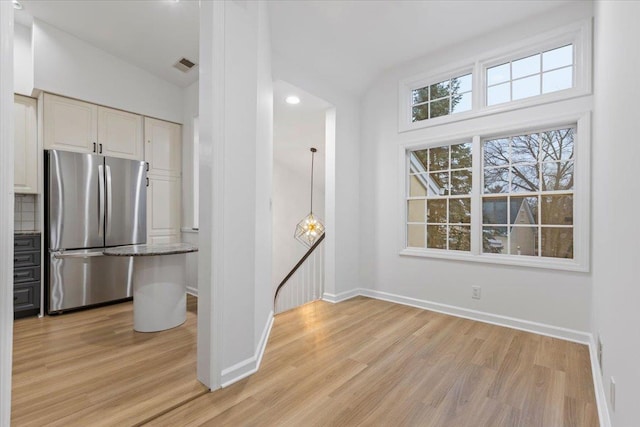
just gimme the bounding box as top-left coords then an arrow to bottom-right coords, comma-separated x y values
32,20 -> 183,123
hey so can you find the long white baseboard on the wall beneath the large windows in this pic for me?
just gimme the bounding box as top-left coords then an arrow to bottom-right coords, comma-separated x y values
358,288 -> 591,344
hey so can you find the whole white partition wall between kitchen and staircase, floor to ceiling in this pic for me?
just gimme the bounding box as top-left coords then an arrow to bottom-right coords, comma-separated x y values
198,2 -> 272,388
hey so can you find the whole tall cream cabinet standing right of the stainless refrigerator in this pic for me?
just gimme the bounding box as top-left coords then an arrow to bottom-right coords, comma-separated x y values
144,117 -> 182,243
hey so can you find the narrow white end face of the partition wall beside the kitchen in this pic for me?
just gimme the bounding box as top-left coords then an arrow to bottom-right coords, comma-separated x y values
197,1 -> 225,390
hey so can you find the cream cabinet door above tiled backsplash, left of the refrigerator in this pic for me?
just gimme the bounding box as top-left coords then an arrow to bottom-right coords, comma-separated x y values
13,95 -> 39,193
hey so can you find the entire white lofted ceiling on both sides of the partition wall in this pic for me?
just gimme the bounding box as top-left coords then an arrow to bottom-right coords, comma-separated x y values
16,0 -> 571,94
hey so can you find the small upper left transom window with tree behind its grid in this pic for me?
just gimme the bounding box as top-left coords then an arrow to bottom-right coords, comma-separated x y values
411,74 -> 472,122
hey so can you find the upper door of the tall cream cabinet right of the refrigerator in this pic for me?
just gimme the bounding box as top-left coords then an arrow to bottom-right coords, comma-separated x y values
144,117 -> 182,176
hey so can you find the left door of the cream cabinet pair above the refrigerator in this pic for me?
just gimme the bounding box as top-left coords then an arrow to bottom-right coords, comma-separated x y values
43,93 -> 98,153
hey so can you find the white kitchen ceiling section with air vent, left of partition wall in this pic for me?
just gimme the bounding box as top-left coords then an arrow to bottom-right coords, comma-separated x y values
15,0 -> 200,87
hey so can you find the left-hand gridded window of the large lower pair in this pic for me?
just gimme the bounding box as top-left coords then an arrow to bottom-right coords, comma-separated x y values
407,142 -> 472,251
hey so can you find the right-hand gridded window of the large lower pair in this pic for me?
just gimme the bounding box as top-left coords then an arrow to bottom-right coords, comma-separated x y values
482,127 -> 575,259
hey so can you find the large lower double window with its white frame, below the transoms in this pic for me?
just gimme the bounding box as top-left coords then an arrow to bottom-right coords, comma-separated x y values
400,113 -> 591,271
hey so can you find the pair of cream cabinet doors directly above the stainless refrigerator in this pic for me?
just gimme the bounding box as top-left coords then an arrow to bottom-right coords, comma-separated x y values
44,93 -> 144,160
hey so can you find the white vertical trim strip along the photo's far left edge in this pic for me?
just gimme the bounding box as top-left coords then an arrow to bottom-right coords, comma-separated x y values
0,1 -> 14,426
